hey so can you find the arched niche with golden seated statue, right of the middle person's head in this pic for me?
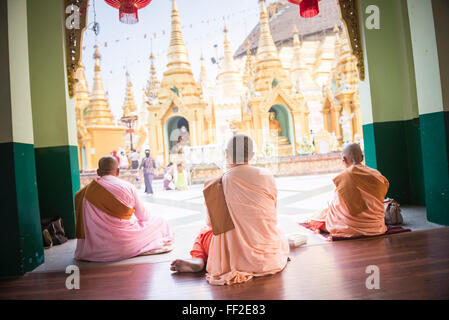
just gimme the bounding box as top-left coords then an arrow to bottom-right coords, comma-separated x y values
268,104 -> 295,155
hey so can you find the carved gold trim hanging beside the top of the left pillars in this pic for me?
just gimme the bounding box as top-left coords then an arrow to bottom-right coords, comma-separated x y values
64,0 -> 89,98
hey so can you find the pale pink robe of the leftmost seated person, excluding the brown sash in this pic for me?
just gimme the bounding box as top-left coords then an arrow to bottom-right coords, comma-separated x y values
75,176 -> 172,262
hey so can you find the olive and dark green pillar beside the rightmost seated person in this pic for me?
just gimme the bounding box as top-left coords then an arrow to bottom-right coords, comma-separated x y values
359,0 -> 425,205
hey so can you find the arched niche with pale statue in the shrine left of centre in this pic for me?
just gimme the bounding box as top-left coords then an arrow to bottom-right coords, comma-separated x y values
165,116 -> 190,159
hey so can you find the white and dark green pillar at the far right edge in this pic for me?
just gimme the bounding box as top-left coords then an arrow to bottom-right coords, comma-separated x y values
407,0 -> 449,225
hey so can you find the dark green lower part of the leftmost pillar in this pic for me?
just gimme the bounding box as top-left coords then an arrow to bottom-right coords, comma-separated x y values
0,142 -> 44,276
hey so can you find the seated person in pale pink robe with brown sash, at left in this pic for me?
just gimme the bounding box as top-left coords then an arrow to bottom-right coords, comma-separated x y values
75,156 -> 172,262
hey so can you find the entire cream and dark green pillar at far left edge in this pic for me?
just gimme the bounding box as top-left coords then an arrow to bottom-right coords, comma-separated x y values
0,0 -> 44,276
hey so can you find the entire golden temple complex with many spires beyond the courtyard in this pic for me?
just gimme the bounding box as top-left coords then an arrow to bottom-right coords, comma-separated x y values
75,0 -> 363,169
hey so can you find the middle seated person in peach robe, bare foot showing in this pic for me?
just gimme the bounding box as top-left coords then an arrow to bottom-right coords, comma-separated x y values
170,134 -> 289,285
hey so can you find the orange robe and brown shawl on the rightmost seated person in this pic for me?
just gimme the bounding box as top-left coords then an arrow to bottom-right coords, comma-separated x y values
309,164 -> 389,238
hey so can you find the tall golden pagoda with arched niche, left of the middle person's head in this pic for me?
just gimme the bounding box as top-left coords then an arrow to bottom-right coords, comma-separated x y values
149,0 -> 211,162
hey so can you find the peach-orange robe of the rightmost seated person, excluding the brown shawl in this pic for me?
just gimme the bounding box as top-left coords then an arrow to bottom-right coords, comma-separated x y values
311,169 -> 388,238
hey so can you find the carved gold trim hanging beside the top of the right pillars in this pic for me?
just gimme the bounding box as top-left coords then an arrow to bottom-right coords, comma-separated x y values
339,0 -> 365,81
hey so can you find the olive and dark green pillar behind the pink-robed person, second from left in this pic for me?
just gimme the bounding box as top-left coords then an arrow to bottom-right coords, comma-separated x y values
27,0 -> 80,238
